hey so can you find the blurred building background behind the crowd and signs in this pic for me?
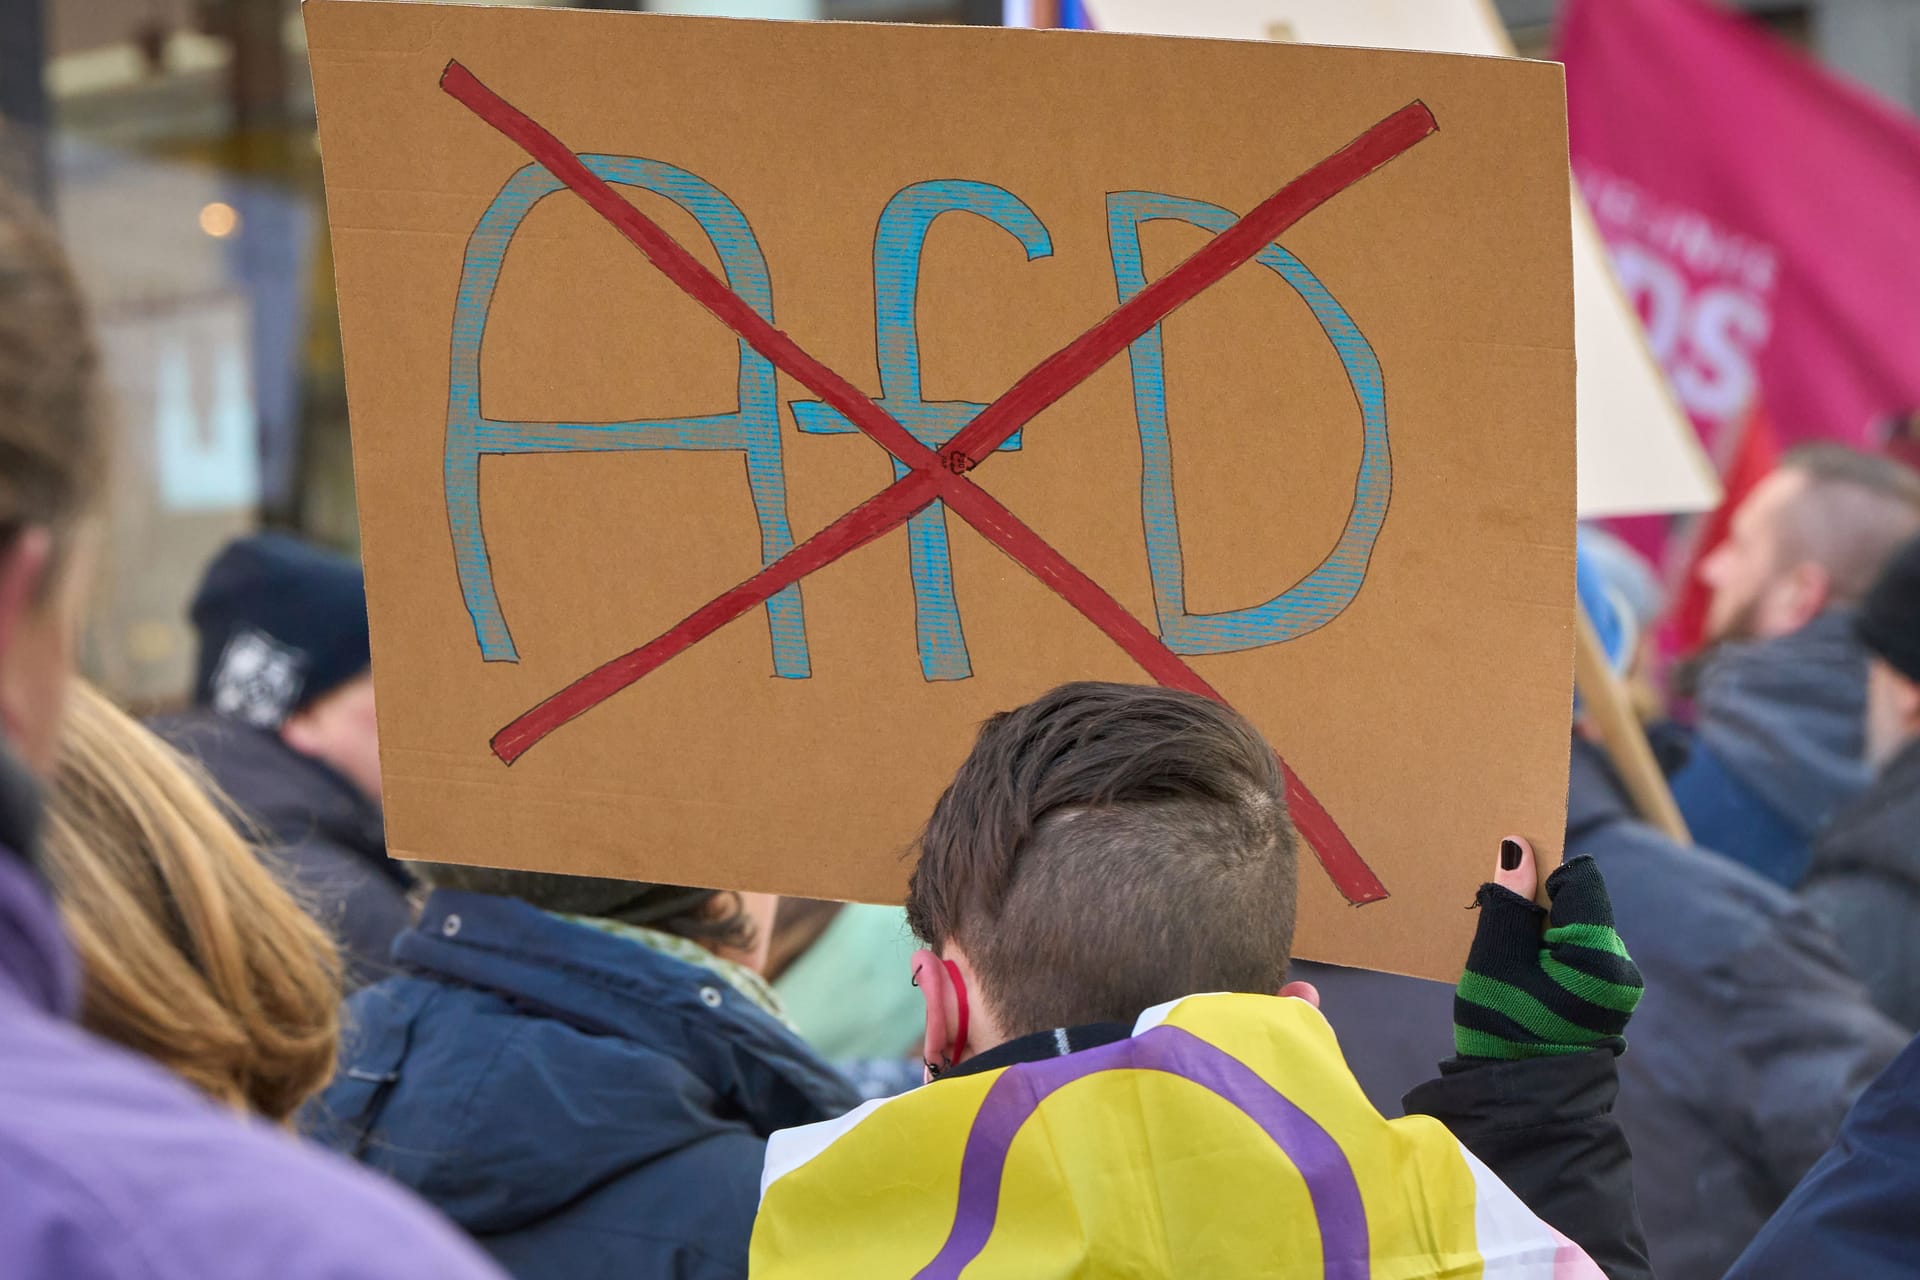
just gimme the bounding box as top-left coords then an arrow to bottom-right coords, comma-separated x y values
0,0 -> 1920,706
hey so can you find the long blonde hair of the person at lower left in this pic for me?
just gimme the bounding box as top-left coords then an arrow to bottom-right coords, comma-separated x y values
42,683 -> 340,1121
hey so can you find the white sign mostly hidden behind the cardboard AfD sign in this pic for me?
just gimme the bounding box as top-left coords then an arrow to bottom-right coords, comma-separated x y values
1087,0 -> 1720,518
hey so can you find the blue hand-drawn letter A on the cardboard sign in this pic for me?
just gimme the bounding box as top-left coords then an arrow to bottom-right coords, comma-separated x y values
445,155 -> 812,679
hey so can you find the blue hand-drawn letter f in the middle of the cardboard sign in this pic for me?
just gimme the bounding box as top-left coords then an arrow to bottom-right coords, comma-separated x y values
793,178 -> 1054,679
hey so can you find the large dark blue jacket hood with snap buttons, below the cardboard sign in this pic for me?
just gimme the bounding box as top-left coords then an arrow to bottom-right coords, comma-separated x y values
317,890 -> 858,1236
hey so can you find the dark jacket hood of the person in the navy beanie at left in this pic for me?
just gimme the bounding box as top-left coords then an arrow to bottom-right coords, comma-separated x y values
150,710 -> 393,883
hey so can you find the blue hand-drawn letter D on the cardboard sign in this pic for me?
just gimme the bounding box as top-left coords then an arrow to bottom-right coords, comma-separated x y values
1106,192 -> 1392,654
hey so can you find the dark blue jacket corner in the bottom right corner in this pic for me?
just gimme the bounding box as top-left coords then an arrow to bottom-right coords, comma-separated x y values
1726,1040 -> 1920,1280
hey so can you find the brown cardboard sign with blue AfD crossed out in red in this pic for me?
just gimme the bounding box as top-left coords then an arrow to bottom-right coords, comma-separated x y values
305,0 -> 1574,977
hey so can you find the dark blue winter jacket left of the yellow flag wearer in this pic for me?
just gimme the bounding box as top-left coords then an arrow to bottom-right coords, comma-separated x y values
303,890 -> 858,1280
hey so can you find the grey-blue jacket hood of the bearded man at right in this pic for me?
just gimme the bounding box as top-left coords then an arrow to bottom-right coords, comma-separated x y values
1699,608 -> 1870,839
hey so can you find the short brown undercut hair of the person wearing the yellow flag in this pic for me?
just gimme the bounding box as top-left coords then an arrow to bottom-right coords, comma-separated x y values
906,683 -> 1296,1036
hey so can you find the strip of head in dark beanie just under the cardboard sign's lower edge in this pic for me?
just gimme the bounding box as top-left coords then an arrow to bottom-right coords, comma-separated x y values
407,862 -> 780,973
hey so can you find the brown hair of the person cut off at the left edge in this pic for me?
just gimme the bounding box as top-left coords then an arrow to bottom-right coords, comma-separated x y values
0,184 -> 106,545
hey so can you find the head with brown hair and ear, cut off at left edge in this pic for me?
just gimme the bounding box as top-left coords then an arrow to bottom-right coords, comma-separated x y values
0,186 -> 106,773
